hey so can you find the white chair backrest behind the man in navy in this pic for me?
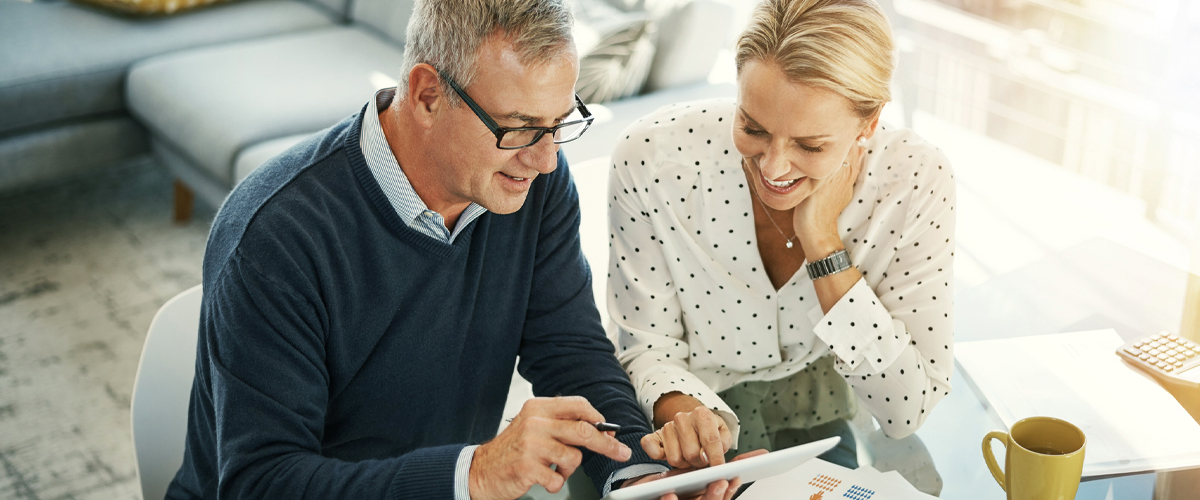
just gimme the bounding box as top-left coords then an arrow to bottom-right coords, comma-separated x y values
130,285 -> 202,500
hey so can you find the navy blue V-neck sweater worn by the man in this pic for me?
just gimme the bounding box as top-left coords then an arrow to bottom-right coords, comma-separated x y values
167,107 -> 667,499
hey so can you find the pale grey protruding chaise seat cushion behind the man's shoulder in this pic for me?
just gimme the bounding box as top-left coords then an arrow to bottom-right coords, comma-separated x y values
127,26 -> 403,186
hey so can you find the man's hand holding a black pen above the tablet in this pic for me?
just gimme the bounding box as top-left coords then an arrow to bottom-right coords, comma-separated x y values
468,397 -> 632,500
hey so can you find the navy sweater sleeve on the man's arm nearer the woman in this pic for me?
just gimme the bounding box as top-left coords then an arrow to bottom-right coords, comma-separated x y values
518,153 -> 665,492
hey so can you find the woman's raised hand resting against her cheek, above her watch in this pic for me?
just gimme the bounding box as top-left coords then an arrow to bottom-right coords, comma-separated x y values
792,145 -> 866,252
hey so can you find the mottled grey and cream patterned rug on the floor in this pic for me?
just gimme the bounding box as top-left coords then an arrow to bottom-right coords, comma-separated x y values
0,158 -> 214,499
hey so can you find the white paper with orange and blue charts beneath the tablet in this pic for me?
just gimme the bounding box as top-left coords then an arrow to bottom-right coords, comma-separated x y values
738,458 -> 935,500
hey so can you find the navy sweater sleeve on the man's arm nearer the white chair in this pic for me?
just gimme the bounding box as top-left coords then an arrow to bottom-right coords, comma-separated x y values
193,253 -> 466,499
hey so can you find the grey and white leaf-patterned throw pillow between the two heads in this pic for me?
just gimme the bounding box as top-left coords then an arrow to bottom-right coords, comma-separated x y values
572,0 -> 655,103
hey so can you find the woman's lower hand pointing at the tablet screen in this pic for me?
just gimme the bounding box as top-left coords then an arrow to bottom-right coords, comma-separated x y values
642,402 -> 733,469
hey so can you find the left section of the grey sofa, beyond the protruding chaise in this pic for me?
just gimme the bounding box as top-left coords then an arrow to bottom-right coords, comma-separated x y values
0,0 -> 347,192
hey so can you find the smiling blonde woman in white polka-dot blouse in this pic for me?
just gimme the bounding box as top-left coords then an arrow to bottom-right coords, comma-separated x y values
608,0 -> 955,468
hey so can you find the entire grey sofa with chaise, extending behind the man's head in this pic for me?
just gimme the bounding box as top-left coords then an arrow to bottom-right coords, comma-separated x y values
0,0 -> 734,221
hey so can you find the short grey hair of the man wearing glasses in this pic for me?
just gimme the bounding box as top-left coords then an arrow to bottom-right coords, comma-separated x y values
400,0 -> 574,107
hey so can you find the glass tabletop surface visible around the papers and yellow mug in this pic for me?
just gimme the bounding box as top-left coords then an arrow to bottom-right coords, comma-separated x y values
910,239 -> 1200,500
